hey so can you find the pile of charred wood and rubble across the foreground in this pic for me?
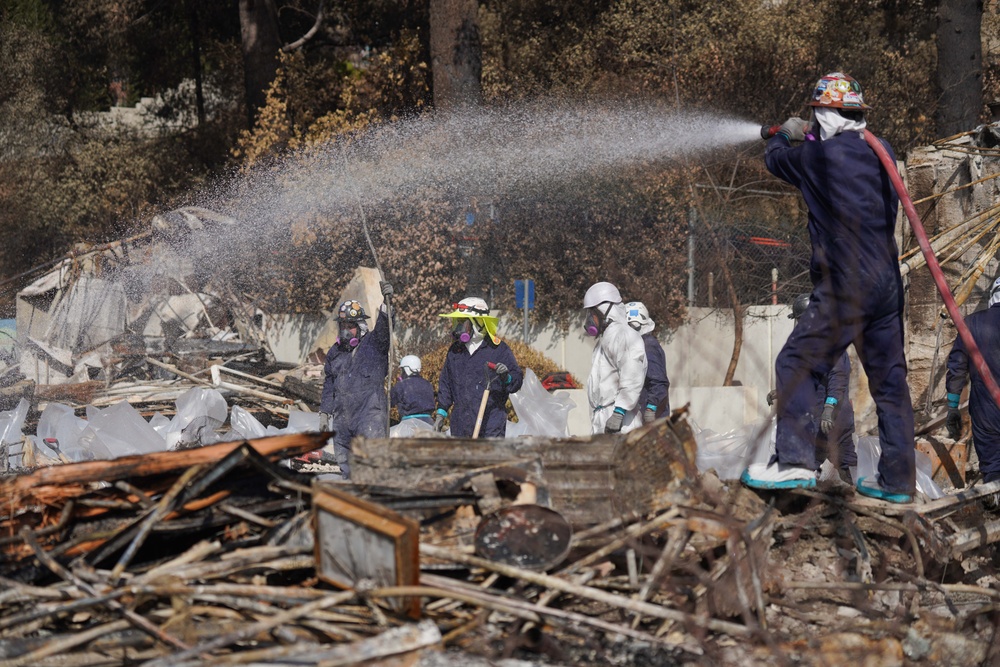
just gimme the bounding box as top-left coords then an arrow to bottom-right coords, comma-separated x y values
0,412 -> 1000,667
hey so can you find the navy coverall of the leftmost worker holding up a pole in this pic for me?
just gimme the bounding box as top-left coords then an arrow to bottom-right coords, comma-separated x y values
319,312 -> 389,479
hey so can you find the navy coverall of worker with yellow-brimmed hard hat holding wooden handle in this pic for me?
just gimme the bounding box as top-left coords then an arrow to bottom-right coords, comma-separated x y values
438,338 -> 524,438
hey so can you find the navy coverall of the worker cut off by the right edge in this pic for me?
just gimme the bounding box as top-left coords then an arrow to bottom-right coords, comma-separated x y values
945,304 -> 1000,482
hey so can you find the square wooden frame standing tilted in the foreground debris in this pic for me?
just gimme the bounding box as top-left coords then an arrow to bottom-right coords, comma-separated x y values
312,483 -> 421,619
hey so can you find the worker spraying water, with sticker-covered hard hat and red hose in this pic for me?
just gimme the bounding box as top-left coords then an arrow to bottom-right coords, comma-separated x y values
742,72 -> 1000,502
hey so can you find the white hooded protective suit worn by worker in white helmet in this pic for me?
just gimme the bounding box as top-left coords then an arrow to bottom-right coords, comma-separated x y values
587,303 -> 646,434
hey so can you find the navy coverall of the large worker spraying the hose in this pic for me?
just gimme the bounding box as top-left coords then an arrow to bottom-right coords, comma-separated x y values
764,131 -> 916,495
